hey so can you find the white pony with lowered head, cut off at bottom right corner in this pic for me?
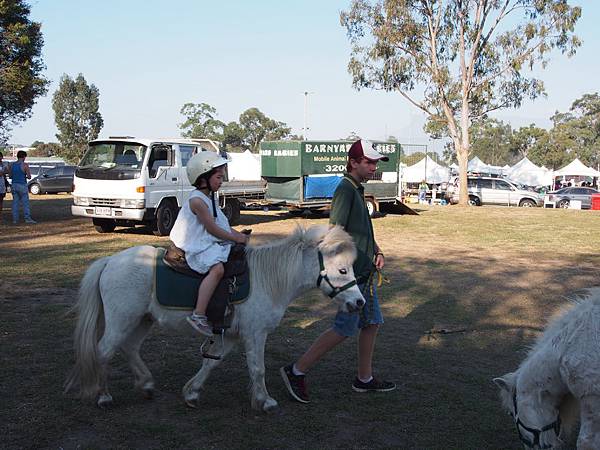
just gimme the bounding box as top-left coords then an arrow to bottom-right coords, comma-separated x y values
494,288 -> 600,450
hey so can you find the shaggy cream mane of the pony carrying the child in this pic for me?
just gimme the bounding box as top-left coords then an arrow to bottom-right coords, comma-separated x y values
246,225 -> 356,299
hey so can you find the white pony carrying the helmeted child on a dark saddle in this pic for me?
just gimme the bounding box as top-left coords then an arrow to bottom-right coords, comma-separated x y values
65,226 -> 365,411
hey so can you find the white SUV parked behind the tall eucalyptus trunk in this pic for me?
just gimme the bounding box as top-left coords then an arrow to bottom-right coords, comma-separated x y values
446,177 -> 543,207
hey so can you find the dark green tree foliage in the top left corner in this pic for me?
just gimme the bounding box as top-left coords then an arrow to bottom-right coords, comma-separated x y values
0,0 -> 49,142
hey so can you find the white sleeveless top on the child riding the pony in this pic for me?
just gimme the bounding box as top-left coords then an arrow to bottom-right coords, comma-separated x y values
169,189 -> 233,273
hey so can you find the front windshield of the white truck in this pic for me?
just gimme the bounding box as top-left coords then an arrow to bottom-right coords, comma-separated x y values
79,142 -> 147,171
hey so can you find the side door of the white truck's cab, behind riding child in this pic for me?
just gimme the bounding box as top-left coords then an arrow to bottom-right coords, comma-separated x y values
146,144 -> 180,208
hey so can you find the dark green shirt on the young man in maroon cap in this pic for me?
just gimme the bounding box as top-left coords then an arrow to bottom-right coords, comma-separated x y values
329,174 -> 375,277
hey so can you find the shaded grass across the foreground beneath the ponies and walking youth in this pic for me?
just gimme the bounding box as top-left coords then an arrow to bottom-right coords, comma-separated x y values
0,243 -> 597,449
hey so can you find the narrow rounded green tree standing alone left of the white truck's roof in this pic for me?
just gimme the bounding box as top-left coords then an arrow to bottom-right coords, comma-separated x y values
52,74 -> 104,162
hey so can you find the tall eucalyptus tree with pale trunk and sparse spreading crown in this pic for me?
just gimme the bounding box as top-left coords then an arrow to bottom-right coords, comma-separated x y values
340,0 -> 581,204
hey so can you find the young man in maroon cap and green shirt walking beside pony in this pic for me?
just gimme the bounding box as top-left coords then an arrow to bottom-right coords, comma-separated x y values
280,140 -> 396,403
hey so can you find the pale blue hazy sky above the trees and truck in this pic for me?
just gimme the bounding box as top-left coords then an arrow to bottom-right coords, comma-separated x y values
9,0 -> 600,152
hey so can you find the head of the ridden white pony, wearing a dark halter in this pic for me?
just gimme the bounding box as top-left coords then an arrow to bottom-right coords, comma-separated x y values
309,226 -> 365,312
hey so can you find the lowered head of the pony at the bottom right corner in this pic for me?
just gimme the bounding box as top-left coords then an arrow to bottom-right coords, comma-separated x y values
493,372 -> 562,449
